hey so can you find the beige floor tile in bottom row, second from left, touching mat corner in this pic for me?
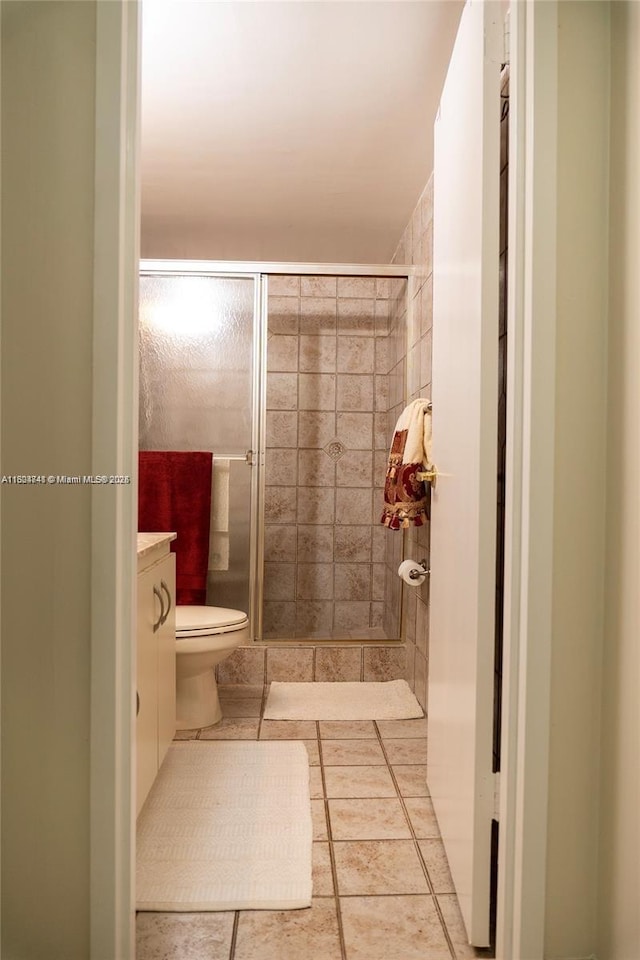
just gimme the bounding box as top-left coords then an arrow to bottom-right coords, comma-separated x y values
234,898 -> 342,960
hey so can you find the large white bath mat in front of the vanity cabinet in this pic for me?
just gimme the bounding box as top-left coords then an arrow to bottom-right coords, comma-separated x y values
136,740 -> 312,911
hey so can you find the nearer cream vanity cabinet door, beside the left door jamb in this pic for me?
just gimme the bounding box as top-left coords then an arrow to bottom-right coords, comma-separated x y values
136,567 -> 161,816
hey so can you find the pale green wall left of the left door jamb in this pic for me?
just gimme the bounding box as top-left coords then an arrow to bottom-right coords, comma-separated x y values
1,2 -> 96,960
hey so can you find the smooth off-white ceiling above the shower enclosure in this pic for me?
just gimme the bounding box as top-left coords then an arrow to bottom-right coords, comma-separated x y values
142,0 -> 463,263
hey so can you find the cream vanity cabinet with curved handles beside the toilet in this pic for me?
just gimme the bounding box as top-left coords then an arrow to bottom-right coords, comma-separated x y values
136,535 -> 176,816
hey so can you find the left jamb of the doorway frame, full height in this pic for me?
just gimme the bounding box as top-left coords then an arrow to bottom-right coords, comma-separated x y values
89,0 -> 140,960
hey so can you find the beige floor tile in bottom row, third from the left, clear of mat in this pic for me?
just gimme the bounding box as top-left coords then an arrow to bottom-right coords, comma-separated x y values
340,895 -> 451,960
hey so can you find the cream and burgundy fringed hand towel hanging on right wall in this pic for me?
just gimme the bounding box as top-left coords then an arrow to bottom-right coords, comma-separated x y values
380,399 -> 431,530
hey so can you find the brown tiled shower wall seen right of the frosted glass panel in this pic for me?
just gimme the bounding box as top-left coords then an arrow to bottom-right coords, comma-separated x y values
263,276 -> 406,640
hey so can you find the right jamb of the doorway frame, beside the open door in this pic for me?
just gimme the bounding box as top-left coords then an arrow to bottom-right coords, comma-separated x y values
496,0 -> 558,960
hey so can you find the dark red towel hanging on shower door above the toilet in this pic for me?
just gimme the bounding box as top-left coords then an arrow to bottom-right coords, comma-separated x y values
138,450 -> 213,605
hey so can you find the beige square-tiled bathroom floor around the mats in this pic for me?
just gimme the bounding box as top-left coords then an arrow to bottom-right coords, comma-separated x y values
136,686 -> 488,960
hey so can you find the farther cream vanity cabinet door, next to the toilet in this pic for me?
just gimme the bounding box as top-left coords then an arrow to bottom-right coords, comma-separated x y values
153,553 -> 176,767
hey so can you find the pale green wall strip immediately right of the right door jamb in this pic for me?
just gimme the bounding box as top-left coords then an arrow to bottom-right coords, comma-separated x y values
538,2 -> 609,958
